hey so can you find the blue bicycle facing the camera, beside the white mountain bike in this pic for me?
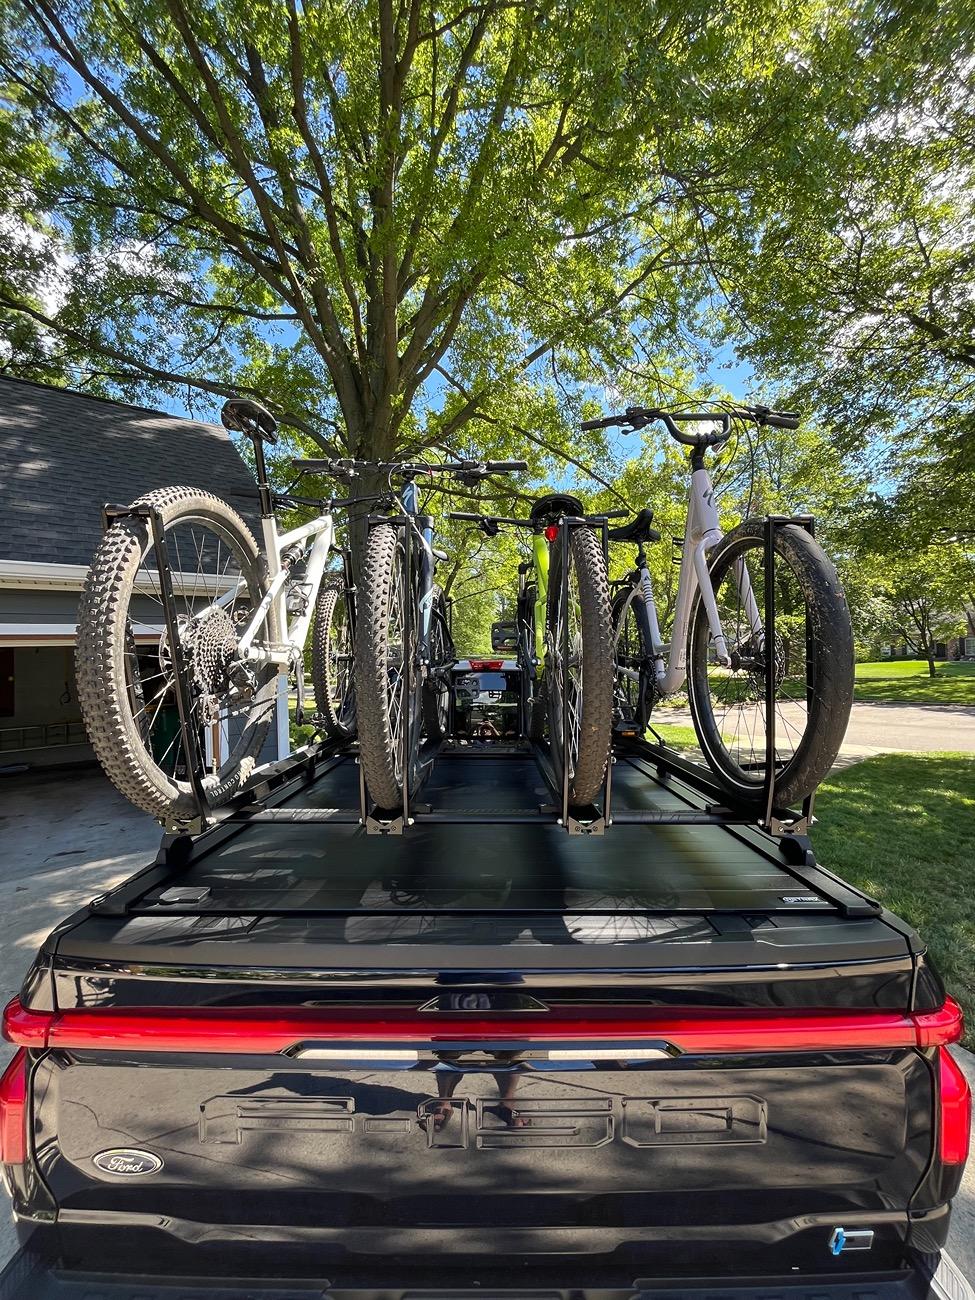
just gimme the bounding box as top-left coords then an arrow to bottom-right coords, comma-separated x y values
355,460 -> 528,810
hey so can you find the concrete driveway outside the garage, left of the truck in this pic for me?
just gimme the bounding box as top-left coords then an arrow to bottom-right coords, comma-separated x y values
0,759 -> 975,1279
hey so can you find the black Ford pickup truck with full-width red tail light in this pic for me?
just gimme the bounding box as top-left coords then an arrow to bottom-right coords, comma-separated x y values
0,722 -> 971,1300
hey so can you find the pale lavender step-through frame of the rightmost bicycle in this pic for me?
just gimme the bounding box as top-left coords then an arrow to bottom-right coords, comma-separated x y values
618,465 -> 762,696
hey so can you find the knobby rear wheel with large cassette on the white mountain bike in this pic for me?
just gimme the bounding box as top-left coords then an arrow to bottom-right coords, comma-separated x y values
77,488 -> 278,818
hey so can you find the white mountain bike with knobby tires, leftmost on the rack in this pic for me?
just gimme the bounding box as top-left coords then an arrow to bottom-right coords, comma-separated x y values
77,399 -> 366,819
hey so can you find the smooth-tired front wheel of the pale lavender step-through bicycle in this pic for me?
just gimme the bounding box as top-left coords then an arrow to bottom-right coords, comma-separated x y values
688,520 -> 853,807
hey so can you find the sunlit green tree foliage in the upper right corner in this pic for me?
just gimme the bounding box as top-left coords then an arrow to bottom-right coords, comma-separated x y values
709,0 -> 975,543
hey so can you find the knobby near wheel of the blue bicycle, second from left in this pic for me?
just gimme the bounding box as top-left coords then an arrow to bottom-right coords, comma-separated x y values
355,524 -> 421,810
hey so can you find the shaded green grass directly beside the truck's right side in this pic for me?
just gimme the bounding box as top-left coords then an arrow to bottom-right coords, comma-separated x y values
813,754 -> 975,1048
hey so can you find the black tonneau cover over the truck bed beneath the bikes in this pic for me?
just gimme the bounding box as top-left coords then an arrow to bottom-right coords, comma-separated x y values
34,750 -> 918,1008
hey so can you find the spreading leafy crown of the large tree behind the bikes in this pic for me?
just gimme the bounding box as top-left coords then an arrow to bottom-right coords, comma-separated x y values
0,0 -> 741,456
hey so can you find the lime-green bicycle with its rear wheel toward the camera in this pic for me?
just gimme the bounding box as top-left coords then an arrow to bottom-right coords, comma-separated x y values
450,493 -> 614,807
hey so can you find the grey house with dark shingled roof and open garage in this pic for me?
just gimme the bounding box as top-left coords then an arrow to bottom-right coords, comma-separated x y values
0,377 -> 287,768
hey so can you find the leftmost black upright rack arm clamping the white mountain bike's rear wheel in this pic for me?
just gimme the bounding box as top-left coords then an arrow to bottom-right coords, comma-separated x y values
101,506 -> 211,836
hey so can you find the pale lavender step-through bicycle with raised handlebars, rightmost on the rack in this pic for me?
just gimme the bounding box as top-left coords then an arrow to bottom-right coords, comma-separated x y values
582,406 -> 853,807
